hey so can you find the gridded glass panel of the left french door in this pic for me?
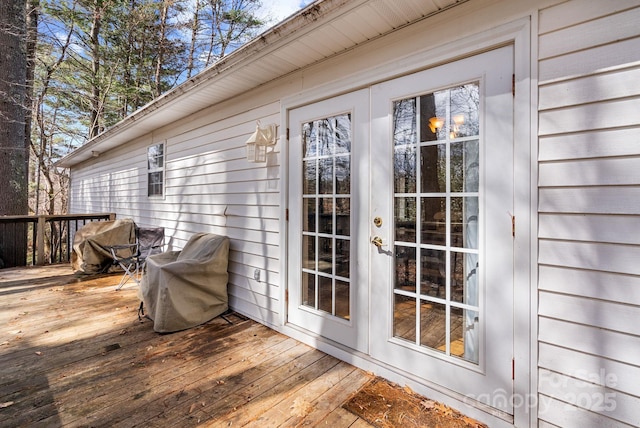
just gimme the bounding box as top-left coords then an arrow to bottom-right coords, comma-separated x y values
300,113 -> 352,320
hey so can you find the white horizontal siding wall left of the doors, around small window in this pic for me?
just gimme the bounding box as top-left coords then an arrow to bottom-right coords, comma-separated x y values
70,96 -> 281,325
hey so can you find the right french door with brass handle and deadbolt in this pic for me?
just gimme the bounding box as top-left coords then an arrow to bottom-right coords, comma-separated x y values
370,47 -> 514,413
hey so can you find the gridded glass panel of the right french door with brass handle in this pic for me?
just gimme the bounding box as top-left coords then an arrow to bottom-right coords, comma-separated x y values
393,82 -> 484,364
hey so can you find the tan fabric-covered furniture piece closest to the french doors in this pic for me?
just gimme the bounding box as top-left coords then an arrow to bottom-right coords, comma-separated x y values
138,233 -> 229,333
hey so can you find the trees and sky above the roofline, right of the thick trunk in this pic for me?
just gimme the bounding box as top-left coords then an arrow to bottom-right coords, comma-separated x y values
31,0 -> 263,216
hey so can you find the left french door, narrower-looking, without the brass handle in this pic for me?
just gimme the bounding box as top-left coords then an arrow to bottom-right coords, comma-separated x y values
288,90 -> 369,352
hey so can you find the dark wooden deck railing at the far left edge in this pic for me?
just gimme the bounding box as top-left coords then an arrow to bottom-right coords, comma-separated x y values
0,213 -> 116,268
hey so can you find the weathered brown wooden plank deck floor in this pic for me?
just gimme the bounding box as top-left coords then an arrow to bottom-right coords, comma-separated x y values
0,266 -> 371,428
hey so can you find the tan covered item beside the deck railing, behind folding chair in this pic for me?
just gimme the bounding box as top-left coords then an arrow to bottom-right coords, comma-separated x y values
71,219 -> 136,274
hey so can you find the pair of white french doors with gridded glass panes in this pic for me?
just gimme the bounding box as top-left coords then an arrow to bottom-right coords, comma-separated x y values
287,46 -> 514,414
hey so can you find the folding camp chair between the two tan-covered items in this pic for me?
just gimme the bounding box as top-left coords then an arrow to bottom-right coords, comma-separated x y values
109,227 -> 164,290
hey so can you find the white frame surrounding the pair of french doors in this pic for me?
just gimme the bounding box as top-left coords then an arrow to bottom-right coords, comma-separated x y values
272,19 -> 538,426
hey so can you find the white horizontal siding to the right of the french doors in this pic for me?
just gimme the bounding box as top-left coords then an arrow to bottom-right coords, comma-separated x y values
538,1 -> 640,427
